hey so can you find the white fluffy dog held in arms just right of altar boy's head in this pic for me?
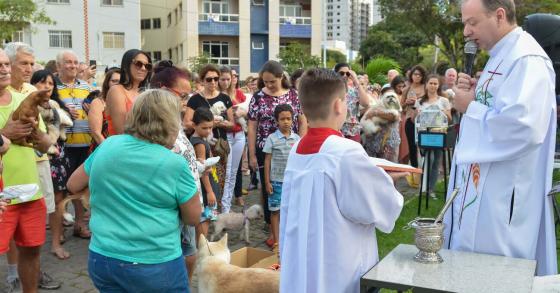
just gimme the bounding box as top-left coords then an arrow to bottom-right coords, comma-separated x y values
360,91 -> 402,134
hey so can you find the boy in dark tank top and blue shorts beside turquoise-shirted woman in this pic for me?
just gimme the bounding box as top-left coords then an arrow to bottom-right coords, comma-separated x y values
191,107 -> 219,242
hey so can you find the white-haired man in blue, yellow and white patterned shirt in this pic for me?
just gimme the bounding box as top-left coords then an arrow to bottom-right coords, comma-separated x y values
56,50 -> 92,239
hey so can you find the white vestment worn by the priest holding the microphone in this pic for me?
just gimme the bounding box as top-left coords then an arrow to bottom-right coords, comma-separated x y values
444,28 -> 557,275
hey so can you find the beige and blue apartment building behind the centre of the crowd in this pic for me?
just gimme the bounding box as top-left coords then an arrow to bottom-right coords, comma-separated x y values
140,0 -> 323,78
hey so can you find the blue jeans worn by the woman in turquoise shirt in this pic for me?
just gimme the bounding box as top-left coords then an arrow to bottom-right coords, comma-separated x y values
88,250 -> 190,293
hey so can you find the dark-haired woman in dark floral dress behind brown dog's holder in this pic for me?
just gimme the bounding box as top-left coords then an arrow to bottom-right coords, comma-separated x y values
31,70 -> 71,260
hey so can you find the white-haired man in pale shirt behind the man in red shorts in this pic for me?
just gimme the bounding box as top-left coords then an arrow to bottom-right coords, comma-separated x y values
4,42 -> 60,289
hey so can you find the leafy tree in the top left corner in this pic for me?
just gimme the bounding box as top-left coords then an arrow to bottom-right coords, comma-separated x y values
0,0 -> 54,40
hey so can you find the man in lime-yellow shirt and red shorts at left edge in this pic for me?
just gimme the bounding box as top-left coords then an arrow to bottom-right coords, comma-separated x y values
0,46 -> 57,292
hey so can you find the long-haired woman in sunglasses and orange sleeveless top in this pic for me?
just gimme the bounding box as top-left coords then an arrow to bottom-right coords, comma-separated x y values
105,49 -> 152,135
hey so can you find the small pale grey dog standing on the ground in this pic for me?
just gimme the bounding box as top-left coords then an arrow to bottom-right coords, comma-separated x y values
210,204 -> 264,243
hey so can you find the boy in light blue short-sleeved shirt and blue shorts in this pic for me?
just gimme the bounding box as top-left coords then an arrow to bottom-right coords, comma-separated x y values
263,104 -> 299,250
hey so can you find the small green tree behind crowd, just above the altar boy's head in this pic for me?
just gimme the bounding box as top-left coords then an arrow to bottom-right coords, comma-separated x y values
278,43 -> 321,73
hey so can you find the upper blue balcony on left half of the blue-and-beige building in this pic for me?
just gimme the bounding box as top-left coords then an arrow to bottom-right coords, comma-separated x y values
198,13 -> 239,36
